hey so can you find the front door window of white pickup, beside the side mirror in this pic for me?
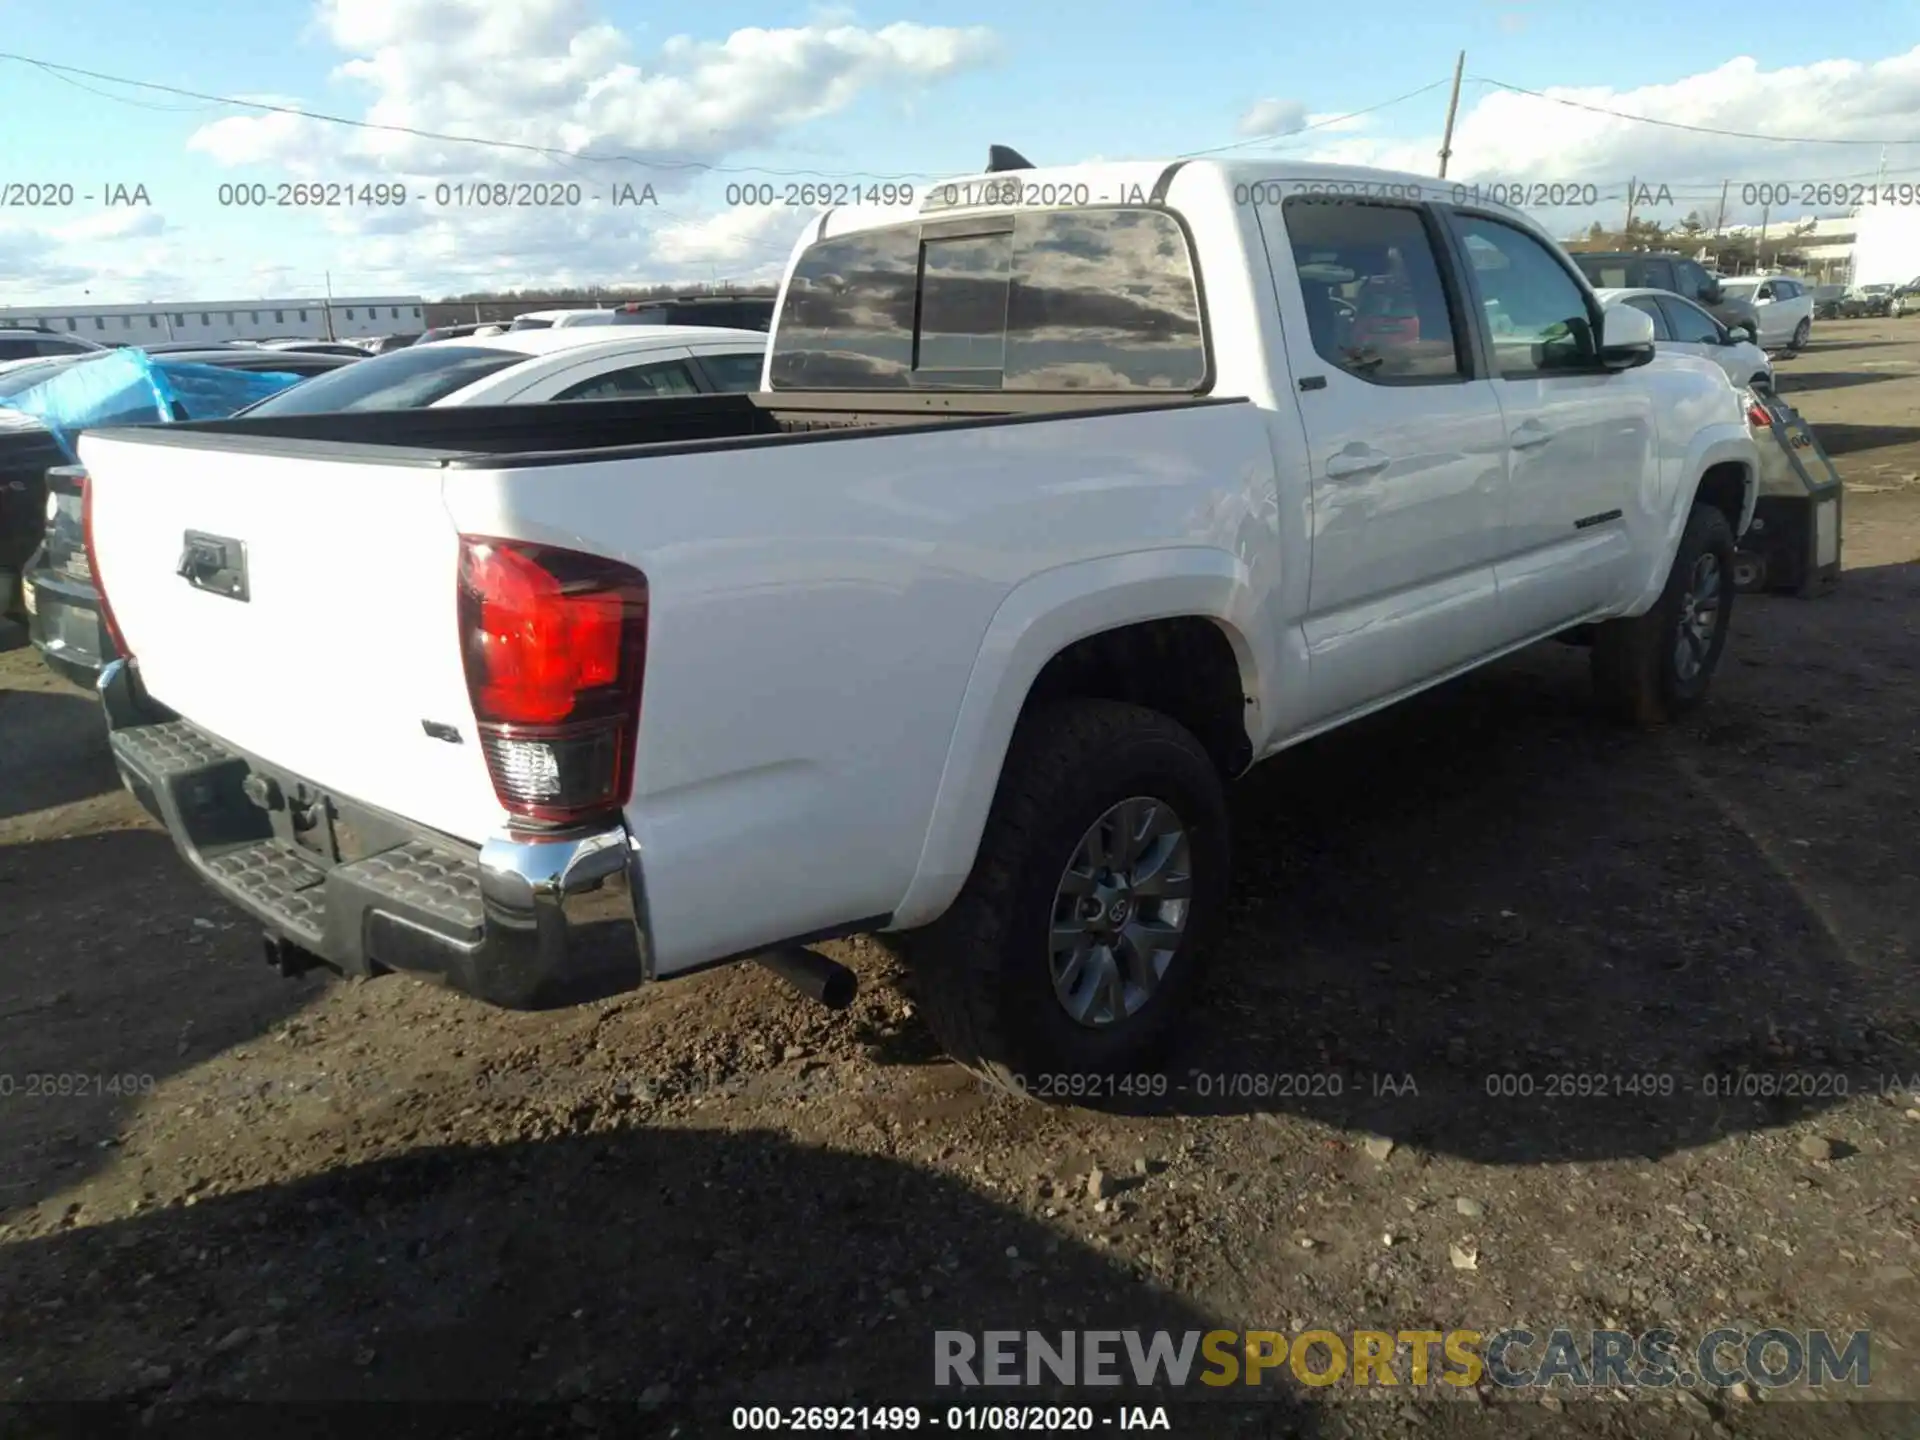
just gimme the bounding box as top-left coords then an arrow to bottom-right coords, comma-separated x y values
1453,213 -> 1599,378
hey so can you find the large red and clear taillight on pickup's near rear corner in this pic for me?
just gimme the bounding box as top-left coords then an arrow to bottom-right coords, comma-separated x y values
459,536 -> 647,826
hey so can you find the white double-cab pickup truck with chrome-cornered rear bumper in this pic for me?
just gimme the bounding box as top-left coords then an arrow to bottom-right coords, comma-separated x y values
81,161 -> 1757,1089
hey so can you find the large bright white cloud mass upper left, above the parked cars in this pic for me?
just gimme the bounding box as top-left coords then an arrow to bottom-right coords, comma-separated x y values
168,0 -> 996,294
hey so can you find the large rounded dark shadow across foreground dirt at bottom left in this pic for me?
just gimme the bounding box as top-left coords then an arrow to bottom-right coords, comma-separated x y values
0,1129 -> 1317,1434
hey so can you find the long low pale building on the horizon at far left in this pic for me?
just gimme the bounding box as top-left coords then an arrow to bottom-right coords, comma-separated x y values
0,296 -> 426,346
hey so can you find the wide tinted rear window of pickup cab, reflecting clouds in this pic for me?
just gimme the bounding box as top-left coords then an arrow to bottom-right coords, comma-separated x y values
770,205 -> 1208,392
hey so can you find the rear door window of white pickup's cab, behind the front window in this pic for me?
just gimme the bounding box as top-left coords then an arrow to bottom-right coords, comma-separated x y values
1267,196 -> 1469,384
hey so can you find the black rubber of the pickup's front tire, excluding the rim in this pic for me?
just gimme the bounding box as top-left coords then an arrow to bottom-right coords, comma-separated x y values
1592,503 -> 1734,726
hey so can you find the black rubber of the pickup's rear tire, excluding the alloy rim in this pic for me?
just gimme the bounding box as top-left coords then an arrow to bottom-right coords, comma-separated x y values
902,701 -> 1231,1098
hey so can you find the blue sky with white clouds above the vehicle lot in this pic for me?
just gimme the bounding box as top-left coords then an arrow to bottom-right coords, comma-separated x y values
0,0 -> 1920,303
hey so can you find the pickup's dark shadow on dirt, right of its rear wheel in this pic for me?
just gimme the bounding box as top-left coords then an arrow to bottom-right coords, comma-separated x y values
898,566 -> 1920,1164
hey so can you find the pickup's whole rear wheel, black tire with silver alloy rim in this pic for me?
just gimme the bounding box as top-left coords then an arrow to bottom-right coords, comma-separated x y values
906,701 -> 1229,1094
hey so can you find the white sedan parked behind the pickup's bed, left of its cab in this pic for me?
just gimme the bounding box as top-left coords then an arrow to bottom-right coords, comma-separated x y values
228,324 -> 766,415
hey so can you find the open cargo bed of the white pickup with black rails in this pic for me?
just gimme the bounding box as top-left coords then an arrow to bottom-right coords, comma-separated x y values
96,390 -> 1242,467
